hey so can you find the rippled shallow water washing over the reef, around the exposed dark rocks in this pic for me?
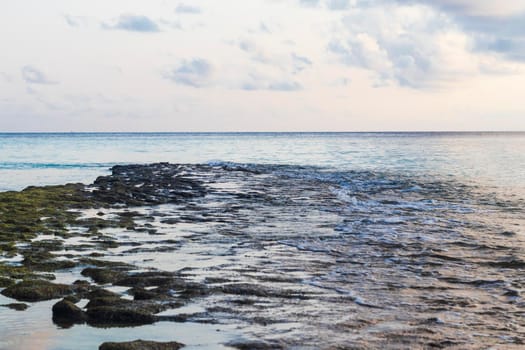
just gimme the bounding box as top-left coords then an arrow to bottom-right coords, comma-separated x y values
0,163 -> 525,349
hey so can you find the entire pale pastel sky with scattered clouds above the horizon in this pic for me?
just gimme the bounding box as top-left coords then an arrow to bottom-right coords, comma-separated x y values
0,0 -> 525,132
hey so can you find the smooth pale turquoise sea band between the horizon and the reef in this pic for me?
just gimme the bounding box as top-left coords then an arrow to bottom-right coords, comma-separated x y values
0,133 -> 525,193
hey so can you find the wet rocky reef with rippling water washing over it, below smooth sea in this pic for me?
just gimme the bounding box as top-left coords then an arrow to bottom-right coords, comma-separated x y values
0,163 -> 525,349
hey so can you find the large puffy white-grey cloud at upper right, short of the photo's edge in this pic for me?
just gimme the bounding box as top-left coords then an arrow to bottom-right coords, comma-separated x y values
328,4 -> 516,88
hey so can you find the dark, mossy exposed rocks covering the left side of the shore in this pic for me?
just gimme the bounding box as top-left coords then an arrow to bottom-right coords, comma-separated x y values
0,163 -> 284,350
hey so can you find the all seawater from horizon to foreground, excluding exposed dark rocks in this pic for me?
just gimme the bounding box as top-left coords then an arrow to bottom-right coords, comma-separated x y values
0,133 -> 525,350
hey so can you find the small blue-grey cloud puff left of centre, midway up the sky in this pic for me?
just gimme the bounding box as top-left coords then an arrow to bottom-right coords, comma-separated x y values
163,58 -> 213,88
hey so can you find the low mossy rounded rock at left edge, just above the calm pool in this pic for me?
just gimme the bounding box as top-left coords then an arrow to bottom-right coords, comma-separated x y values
2,280 -> 74,302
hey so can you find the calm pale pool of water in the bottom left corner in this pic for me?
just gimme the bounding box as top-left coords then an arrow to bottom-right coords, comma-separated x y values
0,295 -> 239,350
